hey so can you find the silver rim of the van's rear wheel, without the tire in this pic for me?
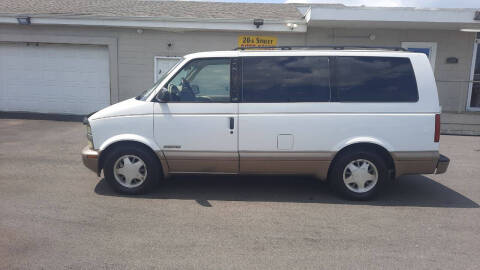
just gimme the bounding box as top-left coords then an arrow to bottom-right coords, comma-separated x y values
343,159 -> 378,193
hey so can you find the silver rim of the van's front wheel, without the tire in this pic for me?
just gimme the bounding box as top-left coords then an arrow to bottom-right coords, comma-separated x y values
113,155 -> 147,188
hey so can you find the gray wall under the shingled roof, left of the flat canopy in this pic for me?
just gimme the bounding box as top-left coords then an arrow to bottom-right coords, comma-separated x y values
0,25 -> 305,100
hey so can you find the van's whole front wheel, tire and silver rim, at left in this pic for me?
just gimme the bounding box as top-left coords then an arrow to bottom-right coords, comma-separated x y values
104,146 -> 159,194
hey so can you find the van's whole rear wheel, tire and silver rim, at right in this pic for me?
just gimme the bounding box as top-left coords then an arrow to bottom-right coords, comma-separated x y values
329,150 -> 388,200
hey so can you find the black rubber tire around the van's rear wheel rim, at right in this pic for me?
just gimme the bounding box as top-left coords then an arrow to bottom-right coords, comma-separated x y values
328,150 -> 388,200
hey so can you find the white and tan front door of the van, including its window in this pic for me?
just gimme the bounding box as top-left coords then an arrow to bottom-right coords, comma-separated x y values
154,58 -> 239,173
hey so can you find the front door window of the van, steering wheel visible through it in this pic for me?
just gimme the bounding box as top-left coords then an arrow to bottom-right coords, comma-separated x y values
165,58 -> 231,103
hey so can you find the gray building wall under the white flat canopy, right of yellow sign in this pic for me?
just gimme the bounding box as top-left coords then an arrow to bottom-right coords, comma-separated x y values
307,28 -> 475,112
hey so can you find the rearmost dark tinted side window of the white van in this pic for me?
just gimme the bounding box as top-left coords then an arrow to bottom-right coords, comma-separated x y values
334,56 -> 418,102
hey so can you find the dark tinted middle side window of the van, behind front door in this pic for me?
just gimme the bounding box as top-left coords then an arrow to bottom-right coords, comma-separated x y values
243,56 -> 330,103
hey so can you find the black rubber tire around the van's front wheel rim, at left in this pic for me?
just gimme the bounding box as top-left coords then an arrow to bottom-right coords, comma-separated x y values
103,146 -> 160,195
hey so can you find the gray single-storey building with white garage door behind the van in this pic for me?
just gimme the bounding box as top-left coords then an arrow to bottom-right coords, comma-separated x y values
0,0 -> 480,135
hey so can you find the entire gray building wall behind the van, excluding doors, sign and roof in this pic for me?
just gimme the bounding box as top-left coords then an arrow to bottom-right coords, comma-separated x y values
0,22 -> 475,113
